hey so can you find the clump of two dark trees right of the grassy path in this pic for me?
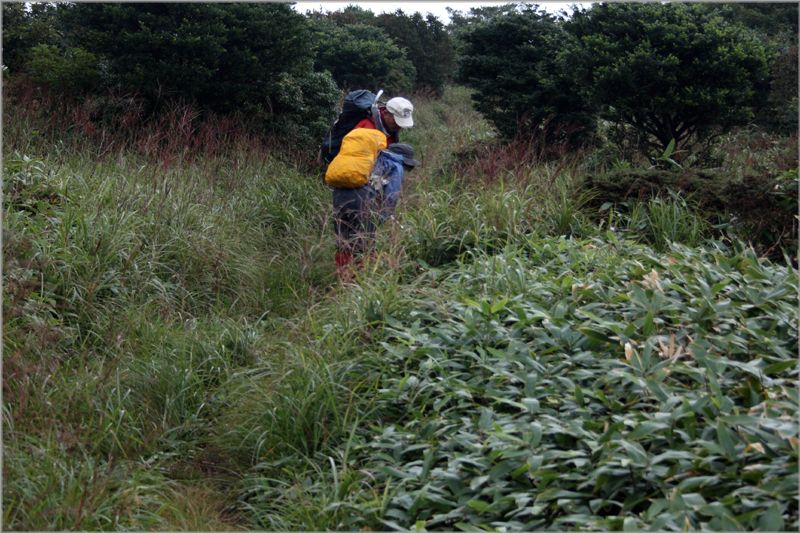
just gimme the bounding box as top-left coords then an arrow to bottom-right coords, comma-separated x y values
454,3 -> 797,155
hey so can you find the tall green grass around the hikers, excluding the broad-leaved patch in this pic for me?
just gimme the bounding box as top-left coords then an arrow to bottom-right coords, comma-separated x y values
3,88 -> 780,530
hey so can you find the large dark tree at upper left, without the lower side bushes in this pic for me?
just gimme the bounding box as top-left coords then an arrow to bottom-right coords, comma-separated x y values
61,3 -> 311,112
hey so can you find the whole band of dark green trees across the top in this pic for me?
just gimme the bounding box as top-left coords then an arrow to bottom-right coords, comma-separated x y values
2,2 -> 797,148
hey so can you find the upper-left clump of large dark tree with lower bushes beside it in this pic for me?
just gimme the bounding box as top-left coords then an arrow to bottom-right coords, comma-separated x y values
27,3 -> 337,146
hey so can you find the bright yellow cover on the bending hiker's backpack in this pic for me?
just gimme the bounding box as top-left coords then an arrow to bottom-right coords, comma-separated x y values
325,128 -> 386,189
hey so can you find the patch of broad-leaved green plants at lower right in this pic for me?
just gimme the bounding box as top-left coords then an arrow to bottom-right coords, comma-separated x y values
239,237 -> 799,530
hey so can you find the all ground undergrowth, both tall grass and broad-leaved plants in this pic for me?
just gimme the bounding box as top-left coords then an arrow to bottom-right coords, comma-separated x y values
3,89 -> 798,530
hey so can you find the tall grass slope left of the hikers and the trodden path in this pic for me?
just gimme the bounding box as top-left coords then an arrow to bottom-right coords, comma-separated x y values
3,118 -> 334,529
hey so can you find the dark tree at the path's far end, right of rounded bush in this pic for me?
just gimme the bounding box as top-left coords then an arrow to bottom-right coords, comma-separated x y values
375,9 -> 455,96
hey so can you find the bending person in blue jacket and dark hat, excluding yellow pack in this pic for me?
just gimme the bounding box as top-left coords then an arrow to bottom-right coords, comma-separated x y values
331,141 -> 420,281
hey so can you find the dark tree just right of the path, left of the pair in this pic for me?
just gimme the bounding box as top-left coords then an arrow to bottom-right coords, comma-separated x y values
456,5 -> 593,144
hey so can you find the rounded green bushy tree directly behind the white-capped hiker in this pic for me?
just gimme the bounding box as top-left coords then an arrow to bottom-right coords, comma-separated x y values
311,17 -> 416,94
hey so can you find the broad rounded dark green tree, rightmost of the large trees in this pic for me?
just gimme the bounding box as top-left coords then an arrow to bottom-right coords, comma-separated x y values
564,3 -> 769,149
